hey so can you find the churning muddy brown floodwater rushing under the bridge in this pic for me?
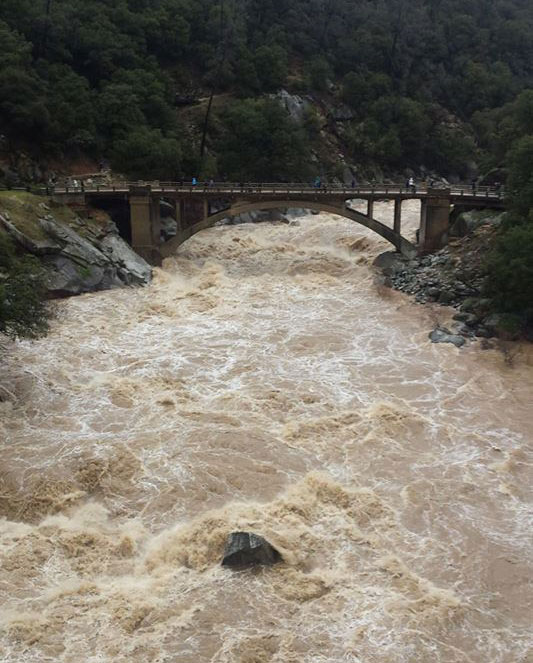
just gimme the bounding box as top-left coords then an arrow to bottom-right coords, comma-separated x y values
0,203 -> 533,663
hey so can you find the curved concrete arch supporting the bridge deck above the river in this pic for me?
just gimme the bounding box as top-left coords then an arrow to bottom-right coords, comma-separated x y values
159,200 -> 417,258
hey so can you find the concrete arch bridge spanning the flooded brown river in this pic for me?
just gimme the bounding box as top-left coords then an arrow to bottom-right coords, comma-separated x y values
52,182 -> 504,265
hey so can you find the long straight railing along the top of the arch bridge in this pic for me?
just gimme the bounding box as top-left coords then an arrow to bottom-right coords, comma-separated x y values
40,181 -> 505,200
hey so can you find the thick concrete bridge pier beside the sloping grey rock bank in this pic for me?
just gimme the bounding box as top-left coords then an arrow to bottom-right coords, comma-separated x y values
129,185 -> 162,266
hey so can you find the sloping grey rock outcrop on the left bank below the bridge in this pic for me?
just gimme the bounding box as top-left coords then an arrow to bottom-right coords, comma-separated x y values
0,192 -> 152,297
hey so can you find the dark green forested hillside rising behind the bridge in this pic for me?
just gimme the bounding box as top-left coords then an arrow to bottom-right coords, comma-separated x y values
0,0 -> 533,179
